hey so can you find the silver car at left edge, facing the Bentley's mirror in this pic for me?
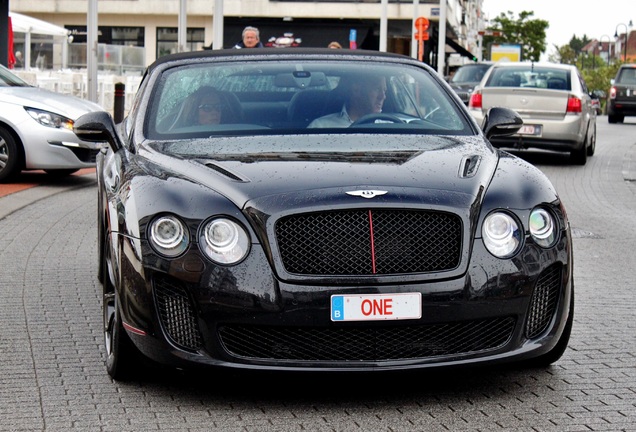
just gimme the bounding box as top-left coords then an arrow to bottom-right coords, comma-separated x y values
0,65 -> 103,182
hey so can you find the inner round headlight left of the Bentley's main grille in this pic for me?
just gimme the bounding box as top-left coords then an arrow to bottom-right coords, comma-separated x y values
199,218 -> 249,264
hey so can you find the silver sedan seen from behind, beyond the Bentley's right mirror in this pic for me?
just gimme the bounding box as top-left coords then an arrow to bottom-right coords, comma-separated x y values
468,62 -> 596,165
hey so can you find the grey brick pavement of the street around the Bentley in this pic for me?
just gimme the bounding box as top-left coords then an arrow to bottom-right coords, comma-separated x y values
0,118 -> 636,432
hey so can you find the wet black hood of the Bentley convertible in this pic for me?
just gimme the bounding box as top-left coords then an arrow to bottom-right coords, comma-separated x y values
145,134 -> 498,211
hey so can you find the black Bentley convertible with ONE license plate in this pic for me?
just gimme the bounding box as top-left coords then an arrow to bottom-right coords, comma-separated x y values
75,49 -> 574,379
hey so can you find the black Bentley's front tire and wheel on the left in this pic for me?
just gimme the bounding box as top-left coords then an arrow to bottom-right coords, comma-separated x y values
102,241 -> 139,381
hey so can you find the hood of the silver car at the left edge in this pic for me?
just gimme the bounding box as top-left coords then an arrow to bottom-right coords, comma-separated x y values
0,87 -> 104,120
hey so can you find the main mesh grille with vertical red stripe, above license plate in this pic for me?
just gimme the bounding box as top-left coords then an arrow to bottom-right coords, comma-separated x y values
275,209 -> 462,276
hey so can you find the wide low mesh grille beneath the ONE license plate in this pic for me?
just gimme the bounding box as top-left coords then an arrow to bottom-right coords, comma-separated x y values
219,317 -> 515,361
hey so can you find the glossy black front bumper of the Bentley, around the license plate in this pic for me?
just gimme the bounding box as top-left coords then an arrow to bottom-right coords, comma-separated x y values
119,236 -> 573,371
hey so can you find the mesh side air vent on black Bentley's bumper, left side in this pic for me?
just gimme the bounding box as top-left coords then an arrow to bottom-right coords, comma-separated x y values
154,277 -> 202,350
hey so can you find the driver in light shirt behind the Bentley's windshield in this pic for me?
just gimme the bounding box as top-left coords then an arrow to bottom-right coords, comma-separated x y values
307,75 -> 386,128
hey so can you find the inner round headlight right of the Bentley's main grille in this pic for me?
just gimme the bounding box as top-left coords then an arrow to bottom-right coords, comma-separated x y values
481,212 -> 521,258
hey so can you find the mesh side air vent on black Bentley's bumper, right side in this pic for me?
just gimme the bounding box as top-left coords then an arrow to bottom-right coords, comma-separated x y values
526,265 -> 561,339
